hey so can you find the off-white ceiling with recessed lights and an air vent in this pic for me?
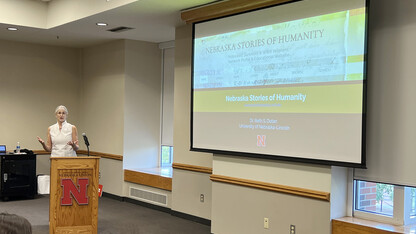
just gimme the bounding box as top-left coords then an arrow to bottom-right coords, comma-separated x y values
0,0 -> 219,48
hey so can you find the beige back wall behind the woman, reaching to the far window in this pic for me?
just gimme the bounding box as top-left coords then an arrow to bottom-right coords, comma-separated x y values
0,37 -> 161,196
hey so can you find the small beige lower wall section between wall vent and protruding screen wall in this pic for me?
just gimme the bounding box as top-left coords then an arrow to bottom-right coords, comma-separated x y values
172,169 -> 212,219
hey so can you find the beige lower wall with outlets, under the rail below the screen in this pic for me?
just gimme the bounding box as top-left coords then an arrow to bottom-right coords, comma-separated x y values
211,182 -> 330,234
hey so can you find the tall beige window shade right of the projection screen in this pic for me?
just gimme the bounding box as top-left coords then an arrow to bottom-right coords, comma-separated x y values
354,0 -> 416,186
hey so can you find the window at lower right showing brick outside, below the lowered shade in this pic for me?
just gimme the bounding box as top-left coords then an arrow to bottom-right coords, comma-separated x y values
354,180 -> 416,225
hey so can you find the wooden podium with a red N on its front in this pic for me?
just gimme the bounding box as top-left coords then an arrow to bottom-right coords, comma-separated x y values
49,157 -> 100,234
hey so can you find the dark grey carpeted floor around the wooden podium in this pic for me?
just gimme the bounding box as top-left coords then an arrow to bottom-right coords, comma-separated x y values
0,195 -> 211,234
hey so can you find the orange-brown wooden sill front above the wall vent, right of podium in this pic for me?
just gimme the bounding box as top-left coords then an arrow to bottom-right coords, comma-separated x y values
124,170 -> 172,191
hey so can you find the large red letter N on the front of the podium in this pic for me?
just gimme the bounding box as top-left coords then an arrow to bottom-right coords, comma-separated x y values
61,178 -> 89,206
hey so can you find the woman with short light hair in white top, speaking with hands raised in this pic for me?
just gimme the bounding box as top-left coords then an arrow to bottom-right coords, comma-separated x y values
38,105 -> 79,157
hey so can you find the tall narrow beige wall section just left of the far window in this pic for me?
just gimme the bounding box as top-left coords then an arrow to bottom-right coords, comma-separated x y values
123,40 -> 162,169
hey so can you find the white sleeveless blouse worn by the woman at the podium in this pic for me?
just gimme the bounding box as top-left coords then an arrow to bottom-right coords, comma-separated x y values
49,121 -> 77,157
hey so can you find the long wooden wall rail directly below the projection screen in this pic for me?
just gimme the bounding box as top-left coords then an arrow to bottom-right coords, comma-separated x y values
211,175 -> 330,202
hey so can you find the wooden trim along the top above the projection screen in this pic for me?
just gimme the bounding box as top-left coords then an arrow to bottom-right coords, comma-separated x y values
181,0 -> 294,24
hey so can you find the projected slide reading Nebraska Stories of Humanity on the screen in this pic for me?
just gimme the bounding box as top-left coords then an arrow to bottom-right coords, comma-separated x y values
192,1 -> 366,164
